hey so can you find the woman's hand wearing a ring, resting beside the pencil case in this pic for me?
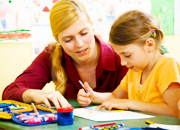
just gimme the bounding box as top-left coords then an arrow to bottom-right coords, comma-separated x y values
23,89 -> 71,109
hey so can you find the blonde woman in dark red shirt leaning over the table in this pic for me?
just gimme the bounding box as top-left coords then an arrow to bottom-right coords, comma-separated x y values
2,0 -> 128,108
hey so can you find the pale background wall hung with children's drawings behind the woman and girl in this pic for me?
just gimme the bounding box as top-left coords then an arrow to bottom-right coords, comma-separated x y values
0,0 -> 180,99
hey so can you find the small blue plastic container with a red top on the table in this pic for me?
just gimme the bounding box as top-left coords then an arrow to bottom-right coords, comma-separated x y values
57,107 -> 74,125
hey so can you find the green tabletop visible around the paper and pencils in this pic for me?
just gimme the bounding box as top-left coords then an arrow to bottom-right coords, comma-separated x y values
0,99 -> 180,130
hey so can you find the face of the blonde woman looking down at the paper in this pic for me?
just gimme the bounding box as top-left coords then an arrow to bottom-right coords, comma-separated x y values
58,16 -> 95,62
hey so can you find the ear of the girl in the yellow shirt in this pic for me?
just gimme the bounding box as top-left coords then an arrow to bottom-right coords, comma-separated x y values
145,38 -> 156,52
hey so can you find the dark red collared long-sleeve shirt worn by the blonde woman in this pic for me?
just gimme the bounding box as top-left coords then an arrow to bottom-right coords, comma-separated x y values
2,37 -> 128,101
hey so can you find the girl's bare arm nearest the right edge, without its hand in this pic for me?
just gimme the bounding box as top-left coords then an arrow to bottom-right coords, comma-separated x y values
129,83 -> 180,118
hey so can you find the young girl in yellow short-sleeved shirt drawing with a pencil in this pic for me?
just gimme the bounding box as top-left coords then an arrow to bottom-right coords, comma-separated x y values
78,10 -> 180,117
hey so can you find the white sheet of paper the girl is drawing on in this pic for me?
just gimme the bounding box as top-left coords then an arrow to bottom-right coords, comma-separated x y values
73,107 -> 155,121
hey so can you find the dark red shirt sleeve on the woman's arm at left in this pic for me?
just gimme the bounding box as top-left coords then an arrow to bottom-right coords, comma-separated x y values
2,50 -> 52,102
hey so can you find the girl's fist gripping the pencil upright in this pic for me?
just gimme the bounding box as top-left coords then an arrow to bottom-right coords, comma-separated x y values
77,82 -> 93,106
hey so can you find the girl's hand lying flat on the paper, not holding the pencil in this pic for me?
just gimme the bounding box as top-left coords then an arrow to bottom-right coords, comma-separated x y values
97,99 -> 129,110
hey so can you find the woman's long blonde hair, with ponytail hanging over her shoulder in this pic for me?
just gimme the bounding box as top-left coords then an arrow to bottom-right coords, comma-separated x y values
50,0 -> 91,94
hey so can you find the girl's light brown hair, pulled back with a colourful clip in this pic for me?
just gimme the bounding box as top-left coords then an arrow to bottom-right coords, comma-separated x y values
109,10 -> 164,49
